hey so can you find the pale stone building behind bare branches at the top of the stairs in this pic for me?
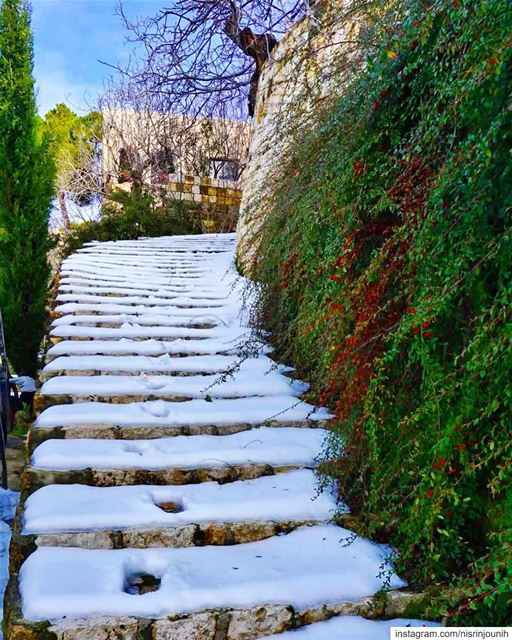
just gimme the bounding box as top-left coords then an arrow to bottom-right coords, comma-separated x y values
102,109 -> 250,229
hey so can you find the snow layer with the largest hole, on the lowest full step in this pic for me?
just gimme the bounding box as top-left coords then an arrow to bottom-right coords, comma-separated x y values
20,525 -> 404,621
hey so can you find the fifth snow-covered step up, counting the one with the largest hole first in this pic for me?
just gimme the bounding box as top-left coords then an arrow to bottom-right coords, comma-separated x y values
41,367 -> 308,402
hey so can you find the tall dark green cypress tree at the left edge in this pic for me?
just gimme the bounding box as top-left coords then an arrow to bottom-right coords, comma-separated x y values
0,0 -> 55,375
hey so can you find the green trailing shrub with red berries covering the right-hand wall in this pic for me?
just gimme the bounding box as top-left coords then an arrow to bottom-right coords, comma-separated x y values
252,0 -> 512,625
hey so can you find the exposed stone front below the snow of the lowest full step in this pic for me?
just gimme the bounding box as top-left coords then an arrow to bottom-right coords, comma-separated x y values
5,574 -> 426,640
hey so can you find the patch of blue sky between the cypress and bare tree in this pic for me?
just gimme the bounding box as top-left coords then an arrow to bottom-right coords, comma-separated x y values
32,0 -> 166,115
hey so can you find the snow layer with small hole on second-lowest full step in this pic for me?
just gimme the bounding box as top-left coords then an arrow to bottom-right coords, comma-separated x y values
23,469 -> 336,534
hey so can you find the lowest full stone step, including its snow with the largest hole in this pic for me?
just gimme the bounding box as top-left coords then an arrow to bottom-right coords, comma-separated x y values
7,525 -> 424,640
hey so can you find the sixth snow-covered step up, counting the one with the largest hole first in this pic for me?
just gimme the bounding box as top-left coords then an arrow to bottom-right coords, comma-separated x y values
42,354 -> 293,379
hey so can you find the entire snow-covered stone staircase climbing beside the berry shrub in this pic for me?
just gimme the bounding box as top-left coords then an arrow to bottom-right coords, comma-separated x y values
5,234 -> 430,640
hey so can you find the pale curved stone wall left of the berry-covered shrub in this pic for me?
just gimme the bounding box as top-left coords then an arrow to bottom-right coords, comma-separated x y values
237,1 -> 361,276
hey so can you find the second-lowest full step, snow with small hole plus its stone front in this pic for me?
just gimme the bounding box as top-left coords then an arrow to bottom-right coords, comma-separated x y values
22,469 -> 337,548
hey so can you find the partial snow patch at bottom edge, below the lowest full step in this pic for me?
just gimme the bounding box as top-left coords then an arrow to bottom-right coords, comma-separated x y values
266,616 -> 440,640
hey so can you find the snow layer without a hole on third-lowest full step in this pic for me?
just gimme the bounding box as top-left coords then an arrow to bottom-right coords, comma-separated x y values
32,427 -> 327,471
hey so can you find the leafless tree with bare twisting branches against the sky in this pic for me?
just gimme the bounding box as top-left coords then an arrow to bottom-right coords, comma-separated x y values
118,0 -> 311,118
